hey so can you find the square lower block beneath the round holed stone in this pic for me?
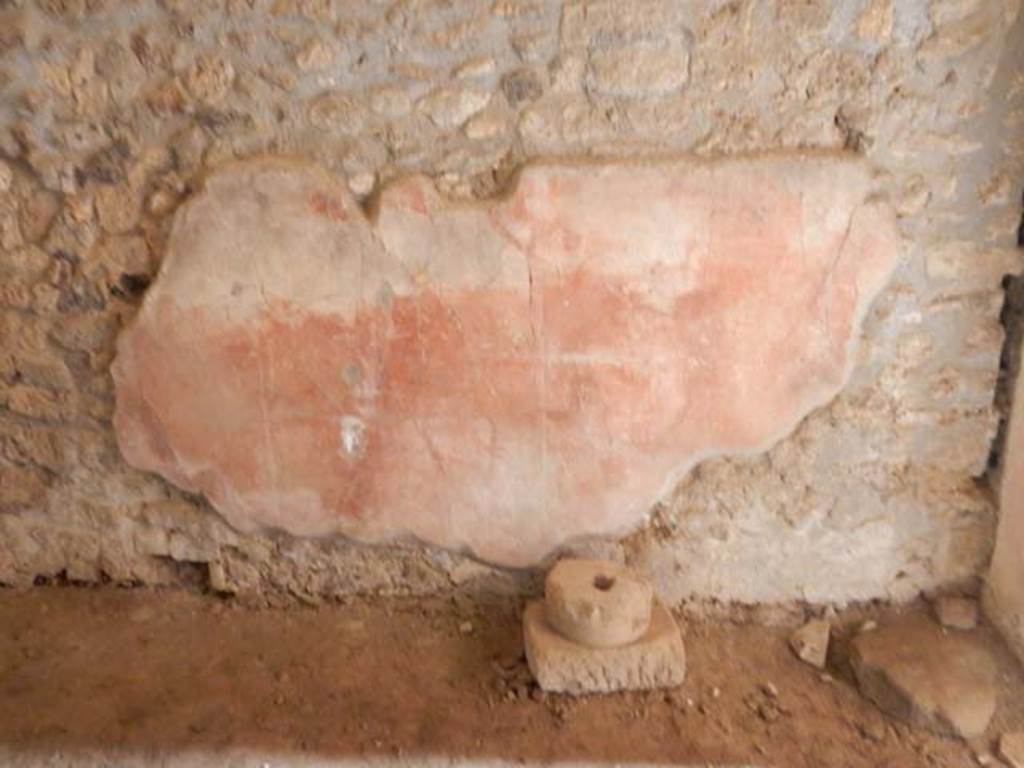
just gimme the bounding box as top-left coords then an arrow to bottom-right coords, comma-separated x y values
522,600 -> 686,694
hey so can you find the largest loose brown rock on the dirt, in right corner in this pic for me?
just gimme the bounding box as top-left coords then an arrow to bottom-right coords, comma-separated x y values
851,616 -> 995,737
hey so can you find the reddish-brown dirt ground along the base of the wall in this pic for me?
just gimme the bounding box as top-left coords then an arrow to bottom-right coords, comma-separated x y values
0,587 -> 1024,768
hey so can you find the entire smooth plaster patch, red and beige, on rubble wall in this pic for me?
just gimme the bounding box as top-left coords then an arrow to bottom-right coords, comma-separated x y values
114,156 -> 898,565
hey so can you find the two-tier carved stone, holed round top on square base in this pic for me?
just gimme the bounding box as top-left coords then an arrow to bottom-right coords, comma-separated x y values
523,560 -> 686,694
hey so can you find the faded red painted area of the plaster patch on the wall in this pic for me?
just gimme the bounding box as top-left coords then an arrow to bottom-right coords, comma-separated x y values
110,157 -> 895,563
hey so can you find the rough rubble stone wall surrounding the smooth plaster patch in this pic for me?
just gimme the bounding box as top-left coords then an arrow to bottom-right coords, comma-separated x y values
0,0 -> 1024,602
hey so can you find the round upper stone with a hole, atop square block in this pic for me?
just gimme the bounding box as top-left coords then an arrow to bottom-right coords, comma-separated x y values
544,560 -> 653,648
